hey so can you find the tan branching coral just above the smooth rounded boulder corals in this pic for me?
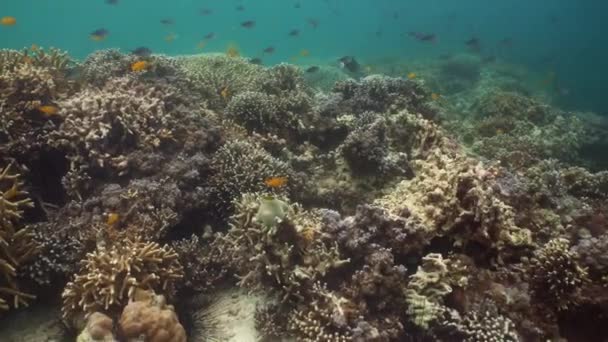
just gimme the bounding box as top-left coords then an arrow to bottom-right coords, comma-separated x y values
62,239 -> 183,319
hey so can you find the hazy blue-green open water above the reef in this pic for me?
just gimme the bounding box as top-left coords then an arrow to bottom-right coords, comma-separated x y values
0,0 -> 608,113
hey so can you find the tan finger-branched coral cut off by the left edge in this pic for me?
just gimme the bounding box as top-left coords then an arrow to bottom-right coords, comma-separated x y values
0,164 -> 39,310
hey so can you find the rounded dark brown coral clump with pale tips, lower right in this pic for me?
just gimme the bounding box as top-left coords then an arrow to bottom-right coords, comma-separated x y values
529,238 -> 588,310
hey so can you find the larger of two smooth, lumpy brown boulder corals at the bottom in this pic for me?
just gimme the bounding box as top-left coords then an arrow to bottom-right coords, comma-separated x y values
118,293 -> 186,342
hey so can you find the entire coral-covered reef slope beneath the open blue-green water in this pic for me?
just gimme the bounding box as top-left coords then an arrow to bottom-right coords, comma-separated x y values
0,49 -> 608,342
